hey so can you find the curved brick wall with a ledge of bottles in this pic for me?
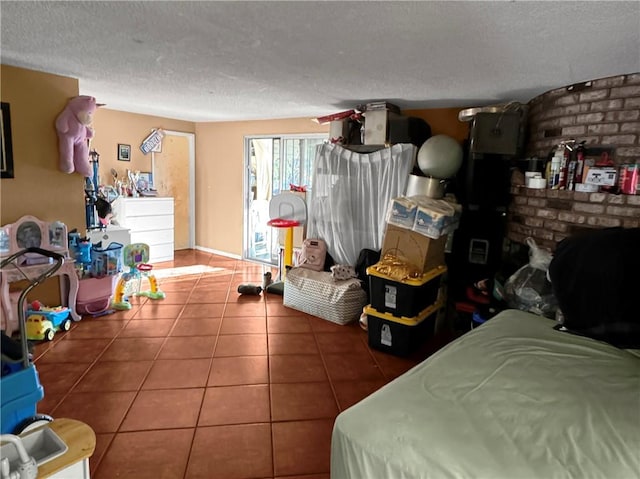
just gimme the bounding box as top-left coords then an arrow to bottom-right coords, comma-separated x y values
507,73 -> 640,251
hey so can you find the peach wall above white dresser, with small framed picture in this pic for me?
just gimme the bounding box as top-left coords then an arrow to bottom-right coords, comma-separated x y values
91,108 -> 195,184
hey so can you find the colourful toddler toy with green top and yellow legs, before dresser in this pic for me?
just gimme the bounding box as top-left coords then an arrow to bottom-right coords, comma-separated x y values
111,243 -> 165,310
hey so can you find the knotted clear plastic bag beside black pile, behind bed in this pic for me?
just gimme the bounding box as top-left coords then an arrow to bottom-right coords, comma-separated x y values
504,238 -> 558,318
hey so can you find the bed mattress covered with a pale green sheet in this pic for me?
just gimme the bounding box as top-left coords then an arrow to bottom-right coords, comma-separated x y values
331,310 -> 640,479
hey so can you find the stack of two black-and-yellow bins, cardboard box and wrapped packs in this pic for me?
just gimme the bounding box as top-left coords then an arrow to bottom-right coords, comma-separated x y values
365,197 -> 461,355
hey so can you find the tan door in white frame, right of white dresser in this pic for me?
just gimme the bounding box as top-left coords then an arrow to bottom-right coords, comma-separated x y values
151,130 -> 195,250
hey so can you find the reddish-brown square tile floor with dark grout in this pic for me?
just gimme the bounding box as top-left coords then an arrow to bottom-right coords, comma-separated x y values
35,250 -> 450,479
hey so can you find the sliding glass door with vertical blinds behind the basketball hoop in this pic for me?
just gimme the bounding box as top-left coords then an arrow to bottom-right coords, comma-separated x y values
243,134 -> 327,266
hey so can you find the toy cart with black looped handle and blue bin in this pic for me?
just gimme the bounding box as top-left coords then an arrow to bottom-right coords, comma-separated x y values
0,247 -> 64,434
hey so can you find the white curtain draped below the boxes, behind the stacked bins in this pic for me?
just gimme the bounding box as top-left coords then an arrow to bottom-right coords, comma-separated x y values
307,143 -> 416,265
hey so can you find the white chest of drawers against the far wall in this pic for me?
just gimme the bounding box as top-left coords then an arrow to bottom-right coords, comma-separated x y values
112,197 -> 174,263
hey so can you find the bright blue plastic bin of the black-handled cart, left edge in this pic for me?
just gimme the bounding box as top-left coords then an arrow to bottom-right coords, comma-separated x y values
0,366 -> 44,434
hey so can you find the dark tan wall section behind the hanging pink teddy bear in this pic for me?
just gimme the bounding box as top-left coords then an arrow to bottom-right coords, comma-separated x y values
0,65 -> 85,230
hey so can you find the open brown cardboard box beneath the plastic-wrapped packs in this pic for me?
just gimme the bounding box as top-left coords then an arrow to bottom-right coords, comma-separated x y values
382,224 -> 447,272
